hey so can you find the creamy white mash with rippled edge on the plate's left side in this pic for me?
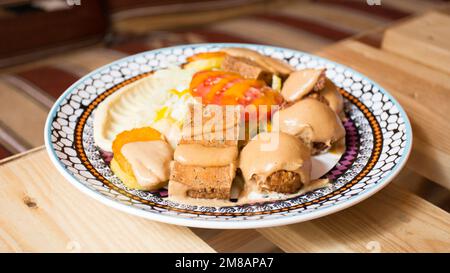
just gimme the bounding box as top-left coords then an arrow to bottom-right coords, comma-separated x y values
94,67 -> 194,152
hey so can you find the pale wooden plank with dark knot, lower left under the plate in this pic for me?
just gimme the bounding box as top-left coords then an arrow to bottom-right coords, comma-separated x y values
0,150 -> 214,252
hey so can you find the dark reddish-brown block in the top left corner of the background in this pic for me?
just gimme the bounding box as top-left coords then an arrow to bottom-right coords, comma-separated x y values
0,0 -> 108,59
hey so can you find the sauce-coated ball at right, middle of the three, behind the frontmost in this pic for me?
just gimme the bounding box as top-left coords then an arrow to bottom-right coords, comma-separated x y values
272,98 -> 345,154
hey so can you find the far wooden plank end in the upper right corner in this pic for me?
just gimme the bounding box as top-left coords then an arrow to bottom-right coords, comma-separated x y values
382,12 -> 450,73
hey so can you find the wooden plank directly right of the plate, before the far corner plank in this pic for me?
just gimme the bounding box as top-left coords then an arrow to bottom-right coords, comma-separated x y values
320,40 -> 450,188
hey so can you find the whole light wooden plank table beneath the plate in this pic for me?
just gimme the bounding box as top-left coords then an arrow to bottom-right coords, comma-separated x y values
0,13 -> 450,252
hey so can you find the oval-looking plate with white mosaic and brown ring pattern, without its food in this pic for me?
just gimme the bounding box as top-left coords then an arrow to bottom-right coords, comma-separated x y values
45,44 -> 412,228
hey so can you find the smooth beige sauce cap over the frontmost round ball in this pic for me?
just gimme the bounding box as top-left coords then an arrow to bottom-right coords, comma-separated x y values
239,132 -> 311,184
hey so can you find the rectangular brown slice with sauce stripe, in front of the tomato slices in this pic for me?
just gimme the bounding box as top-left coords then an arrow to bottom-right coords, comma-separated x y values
169,105 -> 239,200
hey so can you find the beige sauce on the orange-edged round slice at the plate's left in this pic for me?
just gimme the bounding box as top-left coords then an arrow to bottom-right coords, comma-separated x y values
121,140 -> 173,187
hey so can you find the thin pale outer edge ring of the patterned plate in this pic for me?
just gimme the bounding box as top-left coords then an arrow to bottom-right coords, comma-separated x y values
44,43 -> 413,229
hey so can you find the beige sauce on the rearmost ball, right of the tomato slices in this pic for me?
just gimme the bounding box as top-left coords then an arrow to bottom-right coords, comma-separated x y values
281,69 -> 324,101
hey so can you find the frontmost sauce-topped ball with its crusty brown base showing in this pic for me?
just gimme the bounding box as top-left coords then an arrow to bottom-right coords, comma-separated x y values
239,132 -> 311,194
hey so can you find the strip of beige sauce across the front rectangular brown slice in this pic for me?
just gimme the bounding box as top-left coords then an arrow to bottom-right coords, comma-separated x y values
174,144 -> 238,167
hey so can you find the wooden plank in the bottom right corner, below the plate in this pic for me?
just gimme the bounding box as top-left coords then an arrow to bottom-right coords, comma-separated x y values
258,184 -> 450,252
